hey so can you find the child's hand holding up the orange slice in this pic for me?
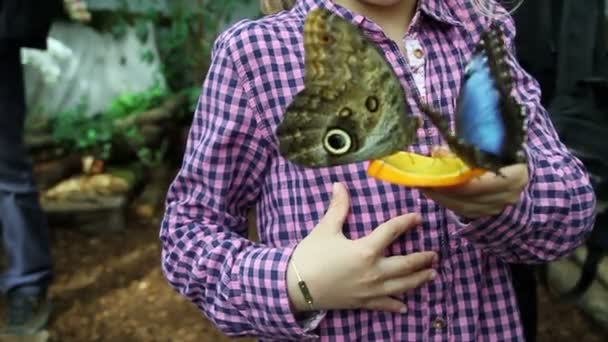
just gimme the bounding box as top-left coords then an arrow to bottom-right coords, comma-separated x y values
421,164 -> 528,219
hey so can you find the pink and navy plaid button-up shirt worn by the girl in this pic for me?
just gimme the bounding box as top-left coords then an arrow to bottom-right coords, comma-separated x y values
161,0 -> 595,341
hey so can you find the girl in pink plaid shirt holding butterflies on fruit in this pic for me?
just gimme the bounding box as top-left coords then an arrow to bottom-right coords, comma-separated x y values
161,0 -> 595,341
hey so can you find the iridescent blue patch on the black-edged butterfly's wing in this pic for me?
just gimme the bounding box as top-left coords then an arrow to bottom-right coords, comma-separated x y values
455,51 -> 508,155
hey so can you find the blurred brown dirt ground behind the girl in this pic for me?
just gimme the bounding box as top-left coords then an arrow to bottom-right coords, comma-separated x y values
1,215 -> 606,342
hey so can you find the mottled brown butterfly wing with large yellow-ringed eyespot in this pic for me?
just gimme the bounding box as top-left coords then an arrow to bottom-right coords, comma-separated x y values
276,8 -> 417,167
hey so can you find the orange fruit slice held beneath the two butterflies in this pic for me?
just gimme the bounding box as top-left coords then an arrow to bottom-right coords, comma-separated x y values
367,152 -> 486,187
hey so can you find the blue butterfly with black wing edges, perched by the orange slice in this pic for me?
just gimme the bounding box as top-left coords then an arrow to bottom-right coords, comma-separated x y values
423,25 -> 527,174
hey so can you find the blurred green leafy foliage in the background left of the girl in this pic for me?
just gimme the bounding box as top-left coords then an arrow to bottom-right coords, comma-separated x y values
52,0 -> 258,164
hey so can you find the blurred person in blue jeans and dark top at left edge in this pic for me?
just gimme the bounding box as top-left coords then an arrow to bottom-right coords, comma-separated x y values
0,0 -> 89,336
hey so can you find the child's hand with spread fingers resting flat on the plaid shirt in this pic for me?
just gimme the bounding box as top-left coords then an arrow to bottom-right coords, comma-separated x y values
287,184 -> 436,312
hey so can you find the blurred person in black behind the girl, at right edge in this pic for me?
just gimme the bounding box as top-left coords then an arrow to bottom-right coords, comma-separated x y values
510,0 -> 608,342
